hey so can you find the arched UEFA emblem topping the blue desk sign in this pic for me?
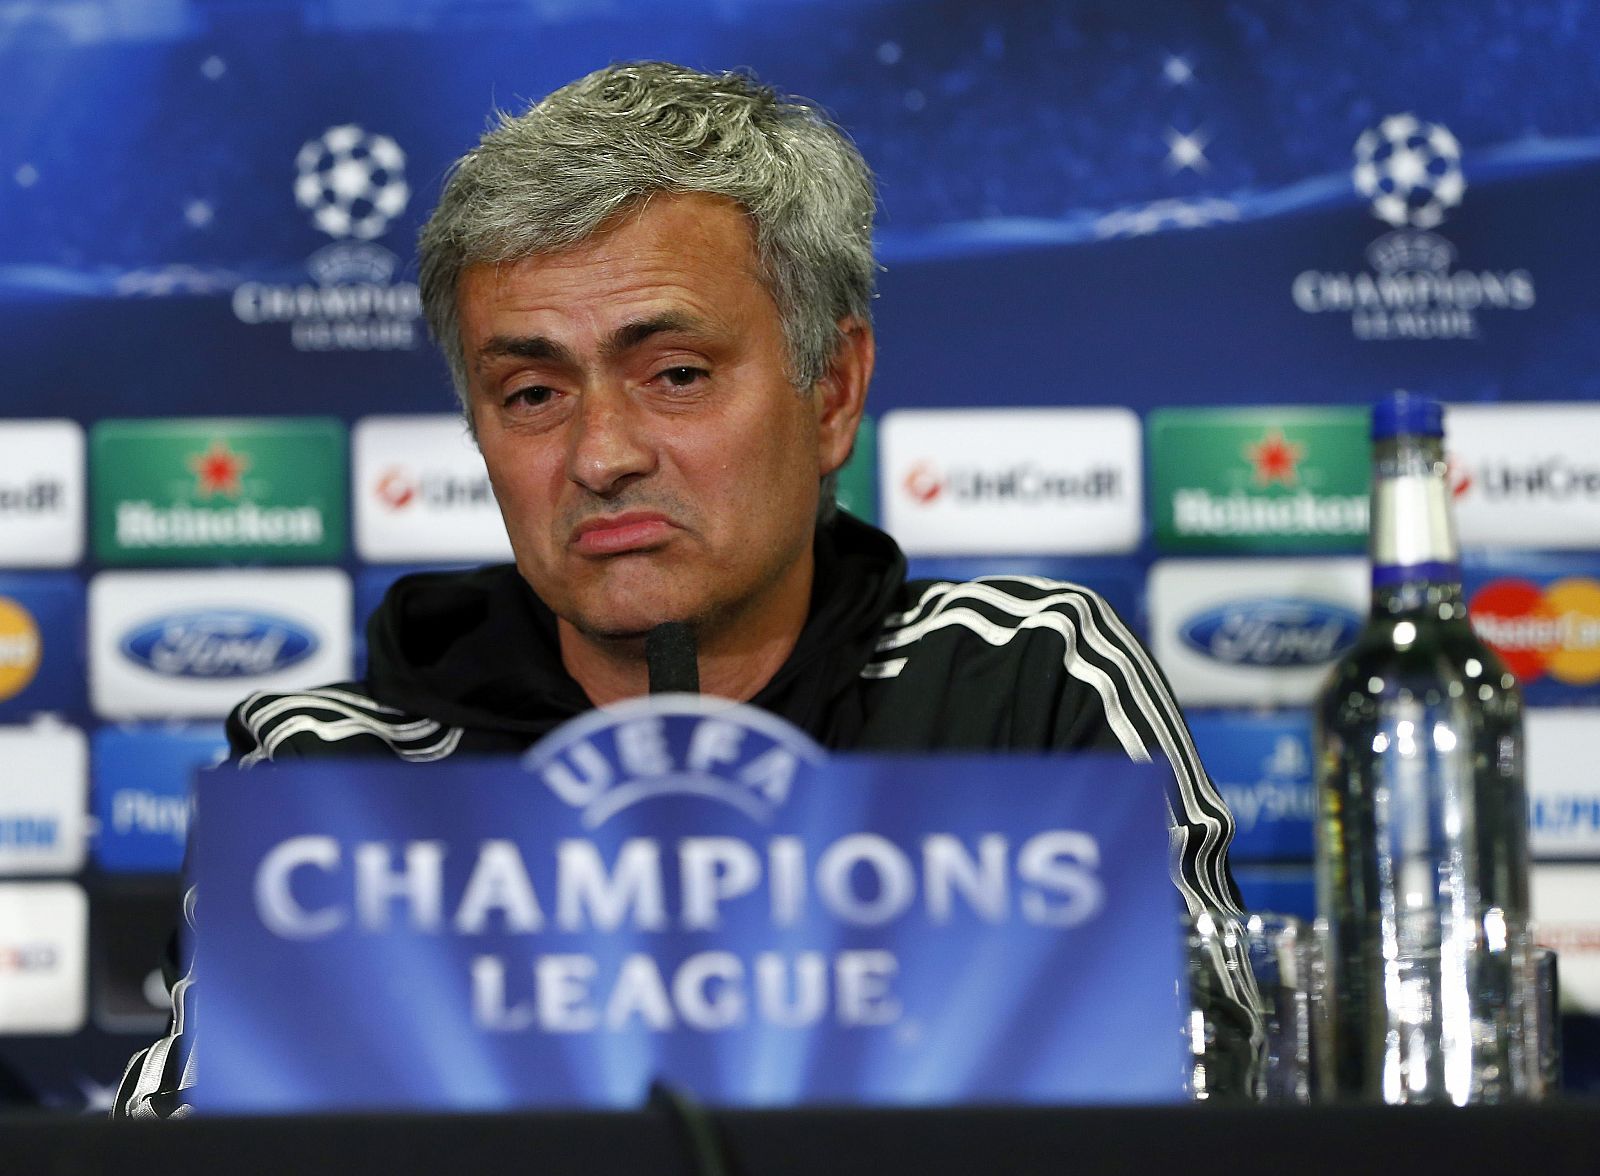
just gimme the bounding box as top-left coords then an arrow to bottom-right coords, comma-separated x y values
522,694 -> 827,829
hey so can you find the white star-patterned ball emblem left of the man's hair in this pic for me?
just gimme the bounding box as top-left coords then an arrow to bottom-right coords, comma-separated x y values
294,123 -> 411,242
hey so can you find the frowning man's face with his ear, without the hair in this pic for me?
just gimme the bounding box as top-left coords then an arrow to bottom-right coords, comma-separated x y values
458,194 -> 859,640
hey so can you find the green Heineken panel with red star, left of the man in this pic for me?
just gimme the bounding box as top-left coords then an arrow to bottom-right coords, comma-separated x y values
91,419 -> 346,563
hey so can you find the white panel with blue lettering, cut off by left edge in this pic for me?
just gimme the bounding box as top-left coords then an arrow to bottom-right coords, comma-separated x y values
0,718 -> 90,874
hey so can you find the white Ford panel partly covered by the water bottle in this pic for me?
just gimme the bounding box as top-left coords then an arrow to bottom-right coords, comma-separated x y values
1149,557 -> 1371,706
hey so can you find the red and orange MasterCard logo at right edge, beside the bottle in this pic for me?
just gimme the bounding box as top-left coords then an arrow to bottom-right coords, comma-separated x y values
1467,576 -> 1600,686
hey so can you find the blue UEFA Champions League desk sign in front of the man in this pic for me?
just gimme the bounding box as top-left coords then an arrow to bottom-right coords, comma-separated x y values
192,694 -> 1184,1112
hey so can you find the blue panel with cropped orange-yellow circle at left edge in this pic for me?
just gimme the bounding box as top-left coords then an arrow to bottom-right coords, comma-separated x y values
0,573 -> 85,722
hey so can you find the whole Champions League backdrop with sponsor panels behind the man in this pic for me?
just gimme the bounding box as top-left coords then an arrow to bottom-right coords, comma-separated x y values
0,0 -> 1600,1106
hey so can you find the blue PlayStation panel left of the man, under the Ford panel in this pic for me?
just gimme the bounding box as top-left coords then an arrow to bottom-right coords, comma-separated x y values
90,723 -> 227,874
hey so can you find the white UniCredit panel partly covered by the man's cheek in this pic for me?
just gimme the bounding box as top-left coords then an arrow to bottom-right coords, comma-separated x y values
352,413 -> 510,563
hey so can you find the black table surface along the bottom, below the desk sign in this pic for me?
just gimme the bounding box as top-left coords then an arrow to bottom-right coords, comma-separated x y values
9,1099 -> 1600,1176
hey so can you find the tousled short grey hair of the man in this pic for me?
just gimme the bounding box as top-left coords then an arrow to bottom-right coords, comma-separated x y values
418,61 -> 877,419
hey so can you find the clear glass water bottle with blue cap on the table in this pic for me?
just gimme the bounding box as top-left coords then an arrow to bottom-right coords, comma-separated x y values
1315,392 -> 1539,1106
